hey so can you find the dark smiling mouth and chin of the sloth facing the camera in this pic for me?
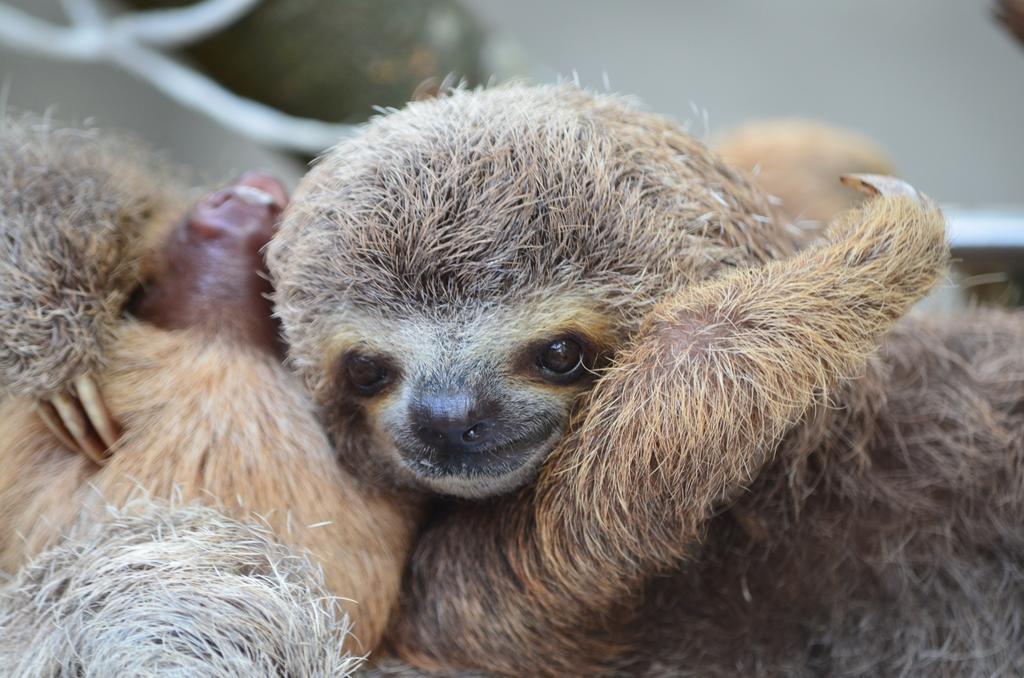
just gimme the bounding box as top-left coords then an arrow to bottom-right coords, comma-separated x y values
398,425 -> 562,497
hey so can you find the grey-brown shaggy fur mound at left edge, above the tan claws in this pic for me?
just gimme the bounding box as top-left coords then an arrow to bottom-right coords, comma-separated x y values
0,117 -> 186,396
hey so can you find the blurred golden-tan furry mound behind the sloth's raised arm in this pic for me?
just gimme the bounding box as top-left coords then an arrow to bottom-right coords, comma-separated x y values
715,120 -> 895,225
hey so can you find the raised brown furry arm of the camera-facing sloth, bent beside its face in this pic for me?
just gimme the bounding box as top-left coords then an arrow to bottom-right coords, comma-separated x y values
391,177 -> 947,674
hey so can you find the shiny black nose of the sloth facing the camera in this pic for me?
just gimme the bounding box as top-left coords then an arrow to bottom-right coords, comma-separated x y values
412,392 -> 497,455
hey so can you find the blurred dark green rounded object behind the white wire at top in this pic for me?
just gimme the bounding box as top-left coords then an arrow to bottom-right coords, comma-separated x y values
126,0 -> 484,122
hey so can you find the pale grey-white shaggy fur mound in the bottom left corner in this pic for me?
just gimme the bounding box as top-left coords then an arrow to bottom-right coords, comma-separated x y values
0,501 -> 360,678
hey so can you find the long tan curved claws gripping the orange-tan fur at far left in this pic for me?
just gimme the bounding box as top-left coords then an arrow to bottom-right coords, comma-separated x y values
38,376 -> 120,466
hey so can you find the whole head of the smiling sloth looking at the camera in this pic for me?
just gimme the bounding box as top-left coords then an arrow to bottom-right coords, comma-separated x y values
268,86 -> 794,497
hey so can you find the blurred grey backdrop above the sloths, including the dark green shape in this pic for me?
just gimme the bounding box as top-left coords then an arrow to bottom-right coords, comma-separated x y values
0,0 -> 1024,302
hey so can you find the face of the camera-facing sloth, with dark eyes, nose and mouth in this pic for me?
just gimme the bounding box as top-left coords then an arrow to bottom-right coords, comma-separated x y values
327,308 -> 608,497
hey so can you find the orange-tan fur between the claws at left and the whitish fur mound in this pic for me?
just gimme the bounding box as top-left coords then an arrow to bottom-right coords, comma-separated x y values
0,325 -> 415,652
